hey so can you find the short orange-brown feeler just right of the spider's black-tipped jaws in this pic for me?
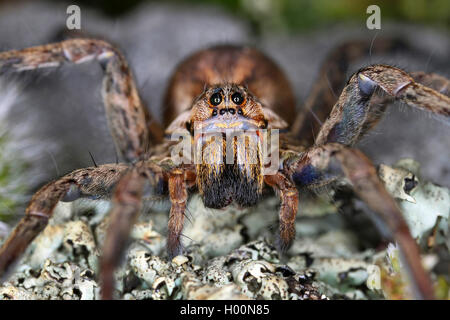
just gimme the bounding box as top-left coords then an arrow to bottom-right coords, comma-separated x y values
264,172 -> 298,252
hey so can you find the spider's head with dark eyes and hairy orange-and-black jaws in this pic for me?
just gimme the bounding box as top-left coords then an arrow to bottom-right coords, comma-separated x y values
190,84 -> 268,208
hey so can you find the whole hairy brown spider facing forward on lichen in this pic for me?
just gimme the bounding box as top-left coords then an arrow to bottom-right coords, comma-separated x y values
0,38 -> 450,299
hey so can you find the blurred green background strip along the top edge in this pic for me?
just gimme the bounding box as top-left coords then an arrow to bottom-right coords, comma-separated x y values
54,0 -> 450,33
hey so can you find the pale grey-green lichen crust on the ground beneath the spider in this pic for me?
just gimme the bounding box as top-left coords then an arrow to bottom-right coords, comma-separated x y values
0,158 -> 448,300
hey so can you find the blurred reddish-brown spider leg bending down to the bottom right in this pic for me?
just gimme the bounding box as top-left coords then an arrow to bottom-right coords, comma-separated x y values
284,143 -> 434,299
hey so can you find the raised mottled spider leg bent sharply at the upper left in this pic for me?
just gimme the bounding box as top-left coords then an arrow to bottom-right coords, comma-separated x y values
0,39 -> 163,162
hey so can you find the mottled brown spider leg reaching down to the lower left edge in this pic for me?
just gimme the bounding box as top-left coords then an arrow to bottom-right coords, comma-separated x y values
0,165 -> 128,279
